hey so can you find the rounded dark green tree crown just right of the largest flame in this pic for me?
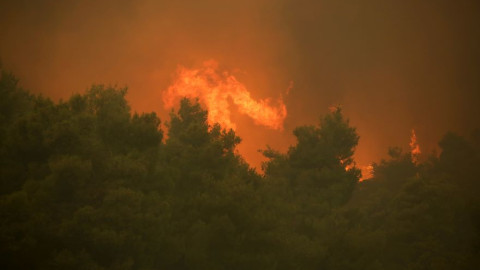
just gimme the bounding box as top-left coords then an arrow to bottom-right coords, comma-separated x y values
264,108 -> 360,206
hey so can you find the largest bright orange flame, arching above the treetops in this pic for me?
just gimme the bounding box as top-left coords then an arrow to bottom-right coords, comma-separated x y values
163,60 -> 287,130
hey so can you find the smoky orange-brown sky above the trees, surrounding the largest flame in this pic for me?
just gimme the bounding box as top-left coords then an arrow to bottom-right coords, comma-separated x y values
0,0 -> 480,171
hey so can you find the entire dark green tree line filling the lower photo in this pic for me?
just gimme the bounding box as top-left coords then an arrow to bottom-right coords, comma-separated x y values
0,70 -> 480,270
